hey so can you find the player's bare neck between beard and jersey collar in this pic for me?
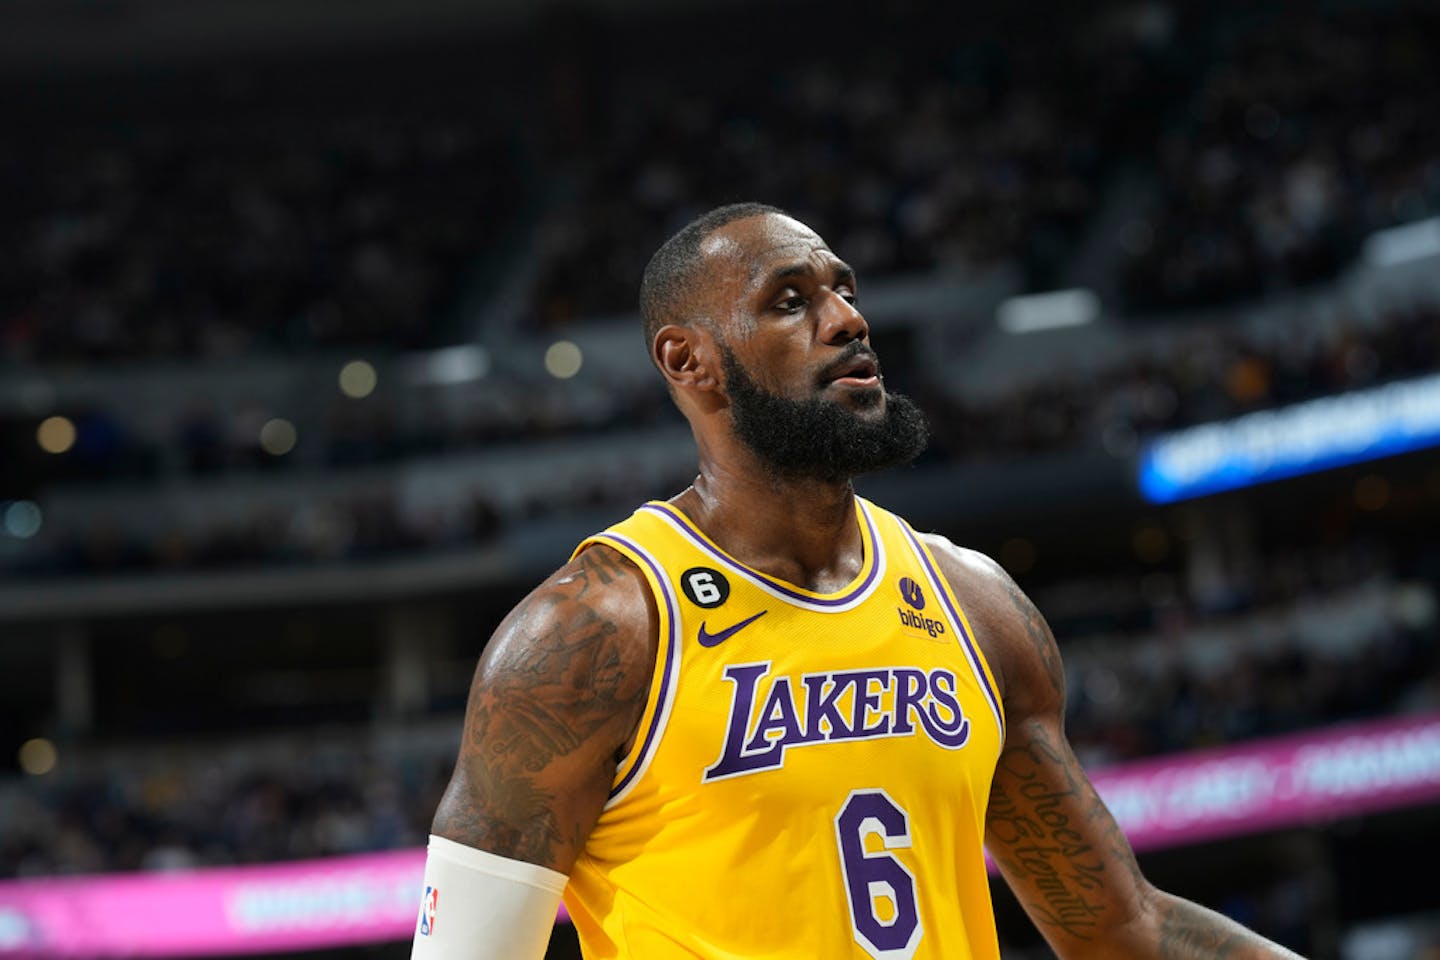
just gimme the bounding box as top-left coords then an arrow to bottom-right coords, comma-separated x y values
674,459 -> 864,593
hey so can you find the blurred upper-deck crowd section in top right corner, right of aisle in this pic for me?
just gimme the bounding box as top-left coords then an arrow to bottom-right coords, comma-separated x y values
1123,4 -> 1440,311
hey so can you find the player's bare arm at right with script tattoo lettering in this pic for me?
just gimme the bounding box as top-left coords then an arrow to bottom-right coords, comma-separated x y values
929,537 -> 1296,960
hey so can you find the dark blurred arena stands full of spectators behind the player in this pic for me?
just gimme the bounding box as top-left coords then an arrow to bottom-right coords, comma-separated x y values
0,0 -> 1440,960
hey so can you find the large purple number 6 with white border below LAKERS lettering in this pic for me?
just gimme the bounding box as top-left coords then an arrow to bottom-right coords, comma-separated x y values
835,790 -> 923,960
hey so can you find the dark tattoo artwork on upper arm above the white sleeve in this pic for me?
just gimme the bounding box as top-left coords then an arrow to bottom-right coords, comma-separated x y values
435,547 -> 648,864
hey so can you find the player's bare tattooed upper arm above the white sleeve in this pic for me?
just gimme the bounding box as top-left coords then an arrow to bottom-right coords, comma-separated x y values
431,545 -> 658,874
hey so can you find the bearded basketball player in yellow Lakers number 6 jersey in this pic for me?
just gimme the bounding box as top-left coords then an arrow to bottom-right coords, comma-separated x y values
412,204 -> 1295,960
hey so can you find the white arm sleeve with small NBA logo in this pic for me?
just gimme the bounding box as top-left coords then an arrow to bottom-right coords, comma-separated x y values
410,835 -> 564,960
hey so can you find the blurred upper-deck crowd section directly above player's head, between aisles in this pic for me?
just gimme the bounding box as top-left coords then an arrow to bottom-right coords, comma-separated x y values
534,4 -> 1169,324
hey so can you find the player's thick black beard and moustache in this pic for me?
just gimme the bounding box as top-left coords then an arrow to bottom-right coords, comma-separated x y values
720,341 -> 930,482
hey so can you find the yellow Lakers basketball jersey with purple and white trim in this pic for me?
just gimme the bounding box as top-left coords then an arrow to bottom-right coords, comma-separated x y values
564,499 -> 1004,960
